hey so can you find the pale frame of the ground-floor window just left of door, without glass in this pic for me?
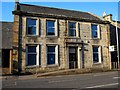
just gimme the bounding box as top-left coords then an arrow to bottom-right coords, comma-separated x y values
46,45 -> 58,65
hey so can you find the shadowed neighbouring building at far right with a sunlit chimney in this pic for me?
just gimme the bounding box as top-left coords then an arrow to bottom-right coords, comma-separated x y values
103,14 -> 120,69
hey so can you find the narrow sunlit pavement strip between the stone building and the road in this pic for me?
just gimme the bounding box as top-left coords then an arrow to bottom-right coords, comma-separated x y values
0,69 -> 119,80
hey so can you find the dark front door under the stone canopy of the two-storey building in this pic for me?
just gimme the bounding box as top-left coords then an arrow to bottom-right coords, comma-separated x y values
69,47 -> 77,69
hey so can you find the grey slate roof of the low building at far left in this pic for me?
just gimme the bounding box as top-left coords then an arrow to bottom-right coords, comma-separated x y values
0,22 -> 13,49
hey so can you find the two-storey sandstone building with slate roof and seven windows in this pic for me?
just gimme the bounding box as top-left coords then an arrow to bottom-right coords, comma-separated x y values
13,2 -> 111,71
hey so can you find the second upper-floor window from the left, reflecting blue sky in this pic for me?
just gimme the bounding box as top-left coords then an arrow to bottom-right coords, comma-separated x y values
46,20 -> 55,35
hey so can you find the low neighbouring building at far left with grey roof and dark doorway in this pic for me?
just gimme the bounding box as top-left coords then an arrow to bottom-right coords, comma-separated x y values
0,22 -> 13,74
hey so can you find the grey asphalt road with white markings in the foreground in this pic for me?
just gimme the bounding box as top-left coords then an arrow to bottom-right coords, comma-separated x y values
2,71 -> 120,90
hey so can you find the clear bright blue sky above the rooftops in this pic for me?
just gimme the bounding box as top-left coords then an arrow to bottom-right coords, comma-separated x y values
0,2 -> 118,22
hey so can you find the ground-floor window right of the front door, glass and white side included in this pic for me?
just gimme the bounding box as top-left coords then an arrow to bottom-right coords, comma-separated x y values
93,46 -> 101,63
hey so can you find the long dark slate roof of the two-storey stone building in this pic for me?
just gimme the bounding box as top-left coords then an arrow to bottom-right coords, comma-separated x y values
13,3 -> 106,21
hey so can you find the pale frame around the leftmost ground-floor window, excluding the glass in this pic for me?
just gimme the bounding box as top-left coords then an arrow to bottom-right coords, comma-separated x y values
26,44 -> 40,66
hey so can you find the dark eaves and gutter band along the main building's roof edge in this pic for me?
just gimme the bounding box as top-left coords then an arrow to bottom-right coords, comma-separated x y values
12,10 -> 108,24
